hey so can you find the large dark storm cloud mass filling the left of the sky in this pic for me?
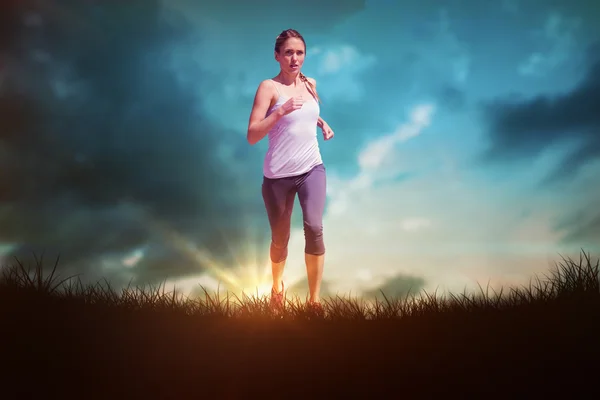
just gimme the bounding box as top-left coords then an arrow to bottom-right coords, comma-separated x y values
0,1 -> 267,288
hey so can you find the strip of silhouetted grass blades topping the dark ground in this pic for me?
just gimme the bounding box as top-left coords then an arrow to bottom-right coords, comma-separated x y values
0,252 -> 600,320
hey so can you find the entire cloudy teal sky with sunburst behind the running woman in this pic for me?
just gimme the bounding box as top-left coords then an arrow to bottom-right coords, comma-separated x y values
0,0 -> 600,297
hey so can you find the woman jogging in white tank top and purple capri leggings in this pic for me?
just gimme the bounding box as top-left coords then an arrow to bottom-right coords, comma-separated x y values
248,29 -> 333,312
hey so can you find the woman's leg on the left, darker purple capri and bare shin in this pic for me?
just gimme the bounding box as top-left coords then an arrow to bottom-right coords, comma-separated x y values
262,178 -> 296,293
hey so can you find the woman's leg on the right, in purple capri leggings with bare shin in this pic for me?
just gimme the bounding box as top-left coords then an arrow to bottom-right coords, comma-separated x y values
298,164 -> 326,303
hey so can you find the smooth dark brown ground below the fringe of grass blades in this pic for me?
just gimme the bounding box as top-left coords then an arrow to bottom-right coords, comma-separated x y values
0,292 -> 600,399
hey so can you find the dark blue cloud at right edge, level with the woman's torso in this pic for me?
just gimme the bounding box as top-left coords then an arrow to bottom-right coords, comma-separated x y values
481,43 -> 600,183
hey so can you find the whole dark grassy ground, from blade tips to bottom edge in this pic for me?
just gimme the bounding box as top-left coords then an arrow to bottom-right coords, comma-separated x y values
0,251 -> 600,399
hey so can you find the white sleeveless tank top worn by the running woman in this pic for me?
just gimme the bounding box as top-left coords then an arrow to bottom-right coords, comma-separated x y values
263,81 -> 323,179
